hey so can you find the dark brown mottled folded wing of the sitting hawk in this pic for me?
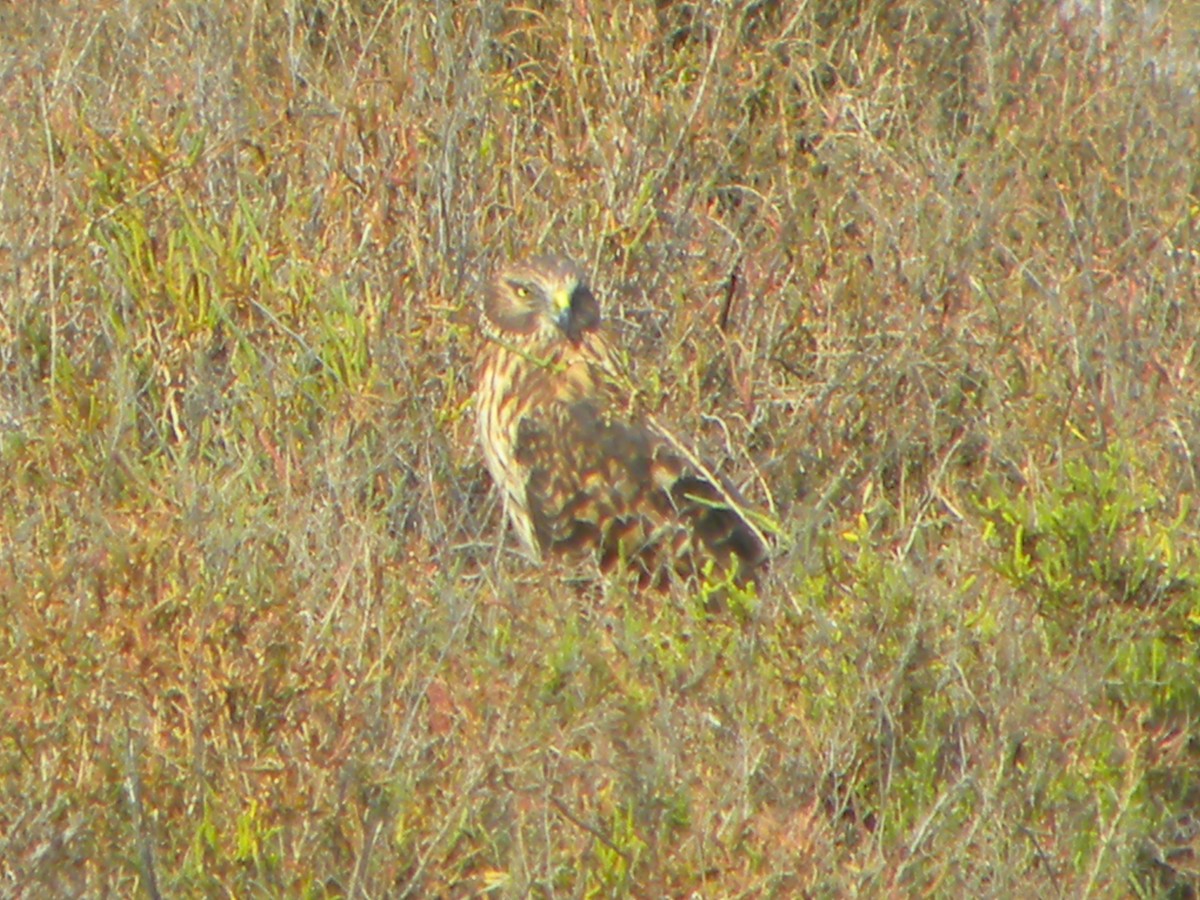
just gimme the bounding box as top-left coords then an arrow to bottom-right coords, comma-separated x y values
515,400 -> 767,581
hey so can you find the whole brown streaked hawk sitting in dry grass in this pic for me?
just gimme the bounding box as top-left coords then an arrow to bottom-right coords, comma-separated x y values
475,256 -> 767,586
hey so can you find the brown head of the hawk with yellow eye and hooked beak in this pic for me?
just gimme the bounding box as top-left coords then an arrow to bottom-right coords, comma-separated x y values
484,257 -> 600,343
